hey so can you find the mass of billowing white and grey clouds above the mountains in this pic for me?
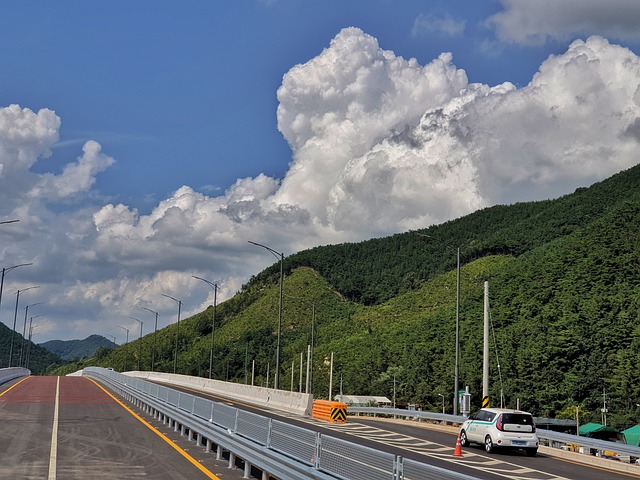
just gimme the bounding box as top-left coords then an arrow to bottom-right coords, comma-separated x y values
0,28 -> 640,338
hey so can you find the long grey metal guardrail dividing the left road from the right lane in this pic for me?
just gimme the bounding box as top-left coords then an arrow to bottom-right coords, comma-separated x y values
83,367 -> 478,480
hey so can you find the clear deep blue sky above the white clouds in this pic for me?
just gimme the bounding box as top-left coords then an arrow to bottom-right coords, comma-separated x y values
0,0 -> 561,211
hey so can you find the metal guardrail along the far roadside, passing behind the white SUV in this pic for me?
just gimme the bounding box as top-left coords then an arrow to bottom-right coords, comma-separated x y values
347,406 -> 640,458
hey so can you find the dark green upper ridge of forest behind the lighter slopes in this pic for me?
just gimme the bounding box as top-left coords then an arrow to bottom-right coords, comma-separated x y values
282,166 -> 640,305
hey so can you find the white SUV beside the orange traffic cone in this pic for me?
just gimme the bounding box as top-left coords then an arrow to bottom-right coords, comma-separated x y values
460,408 -> 538,457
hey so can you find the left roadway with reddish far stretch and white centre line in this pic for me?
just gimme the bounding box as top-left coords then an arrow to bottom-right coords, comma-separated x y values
0,377 -> 225,480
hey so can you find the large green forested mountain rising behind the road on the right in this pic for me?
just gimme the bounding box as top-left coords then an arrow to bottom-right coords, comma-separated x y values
53,167 -> 640,427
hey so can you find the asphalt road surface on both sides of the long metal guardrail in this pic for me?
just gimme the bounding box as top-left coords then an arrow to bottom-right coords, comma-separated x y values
6,377 -> 640,480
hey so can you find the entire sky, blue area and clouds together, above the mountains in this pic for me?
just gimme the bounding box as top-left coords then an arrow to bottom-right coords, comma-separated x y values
0,0 -> 640,341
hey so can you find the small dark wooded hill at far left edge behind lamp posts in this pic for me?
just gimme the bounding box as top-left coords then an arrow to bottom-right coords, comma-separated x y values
0,322 -> 65,375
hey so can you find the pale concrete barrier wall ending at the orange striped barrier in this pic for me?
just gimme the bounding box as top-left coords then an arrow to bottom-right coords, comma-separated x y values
123,371 -> 313,416
